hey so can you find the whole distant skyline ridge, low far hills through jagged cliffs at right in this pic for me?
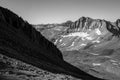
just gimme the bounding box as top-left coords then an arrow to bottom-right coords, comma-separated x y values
34,16 -> 120,36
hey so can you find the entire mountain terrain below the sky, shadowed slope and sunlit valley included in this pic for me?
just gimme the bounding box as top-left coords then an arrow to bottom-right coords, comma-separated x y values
0,7 -> 120,80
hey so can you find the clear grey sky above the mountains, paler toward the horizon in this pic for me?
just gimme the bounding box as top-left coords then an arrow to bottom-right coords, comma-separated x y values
0,0 -> 120,24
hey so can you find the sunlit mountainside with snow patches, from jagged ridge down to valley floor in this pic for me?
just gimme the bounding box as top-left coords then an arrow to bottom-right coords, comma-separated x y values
34,17 -> 120,80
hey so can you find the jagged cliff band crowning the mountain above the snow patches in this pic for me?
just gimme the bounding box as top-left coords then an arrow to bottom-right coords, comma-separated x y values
64,17 -> 120,36
